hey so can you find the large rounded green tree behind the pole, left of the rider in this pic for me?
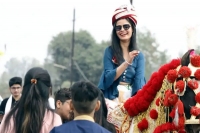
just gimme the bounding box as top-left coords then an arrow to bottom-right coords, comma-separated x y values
48,30 -> 105,84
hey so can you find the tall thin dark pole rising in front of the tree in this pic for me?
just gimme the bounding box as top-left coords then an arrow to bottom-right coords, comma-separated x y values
70,8 -> 75,86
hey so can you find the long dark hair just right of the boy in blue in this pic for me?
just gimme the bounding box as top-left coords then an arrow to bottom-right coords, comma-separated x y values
94,91 -> 116,133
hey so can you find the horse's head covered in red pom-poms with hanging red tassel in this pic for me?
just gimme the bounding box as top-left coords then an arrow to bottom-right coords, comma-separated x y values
167,49 -> 200,132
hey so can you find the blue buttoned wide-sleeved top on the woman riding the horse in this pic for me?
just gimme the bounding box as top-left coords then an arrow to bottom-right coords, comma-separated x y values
98,47 -> 146,100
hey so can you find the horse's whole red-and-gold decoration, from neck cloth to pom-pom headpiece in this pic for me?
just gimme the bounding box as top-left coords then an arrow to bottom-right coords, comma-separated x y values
108,51 -> 200,133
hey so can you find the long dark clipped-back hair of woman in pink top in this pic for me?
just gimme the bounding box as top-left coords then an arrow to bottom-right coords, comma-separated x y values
4,67 -> 53,133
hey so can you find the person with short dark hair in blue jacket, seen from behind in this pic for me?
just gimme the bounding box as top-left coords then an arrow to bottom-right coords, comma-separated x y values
50,81 -> 111,133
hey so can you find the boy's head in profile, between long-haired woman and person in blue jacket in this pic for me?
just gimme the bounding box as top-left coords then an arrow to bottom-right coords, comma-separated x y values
54,88 -> 73,122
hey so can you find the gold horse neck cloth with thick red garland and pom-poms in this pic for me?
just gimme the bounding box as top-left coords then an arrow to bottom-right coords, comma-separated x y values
108,59 -> 180,133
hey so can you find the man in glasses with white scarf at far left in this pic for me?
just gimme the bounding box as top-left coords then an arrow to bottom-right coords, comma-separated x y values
0,77 -> 22,120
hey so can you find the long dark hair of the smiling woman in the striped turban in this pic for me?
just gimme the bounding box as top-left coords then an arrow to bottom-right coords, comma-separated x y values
111,18 -> 137,64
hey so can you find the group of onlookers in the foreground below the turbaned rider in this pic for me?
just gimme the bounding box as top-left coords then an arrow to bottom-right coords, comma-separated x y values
0,67 -> 115,133
